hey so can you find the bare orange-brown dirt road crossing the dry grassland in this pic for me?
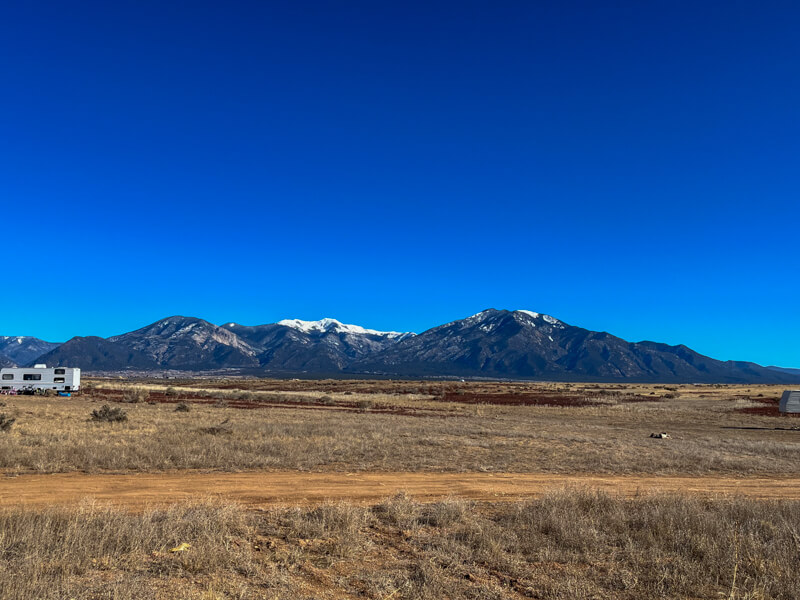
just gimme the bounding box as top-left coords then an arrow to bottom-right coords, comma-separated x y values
0,471 -> 800,510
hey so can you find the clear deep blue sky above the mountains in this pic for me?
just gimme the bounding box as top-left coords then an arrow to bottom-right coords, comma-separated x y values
0,0 -> 800,367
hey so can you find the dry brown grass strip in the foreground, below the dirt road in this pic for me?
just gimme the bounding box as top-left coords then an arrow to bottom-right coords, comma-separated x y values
0,489 -> 800,600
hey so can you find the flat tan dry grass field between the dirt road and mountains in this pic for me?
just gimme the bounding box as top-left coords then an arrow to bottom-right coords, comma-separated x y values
0,382 -> 800,475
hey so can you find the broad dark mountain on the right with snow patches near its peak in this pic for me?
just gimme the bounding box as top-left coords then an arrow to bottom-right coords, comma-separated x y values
349,309 -> 791,382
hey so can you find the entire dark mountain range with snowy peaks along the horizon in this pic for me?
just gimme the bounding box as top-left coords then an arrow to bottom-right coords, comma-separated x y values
0,309 -> 800,383
